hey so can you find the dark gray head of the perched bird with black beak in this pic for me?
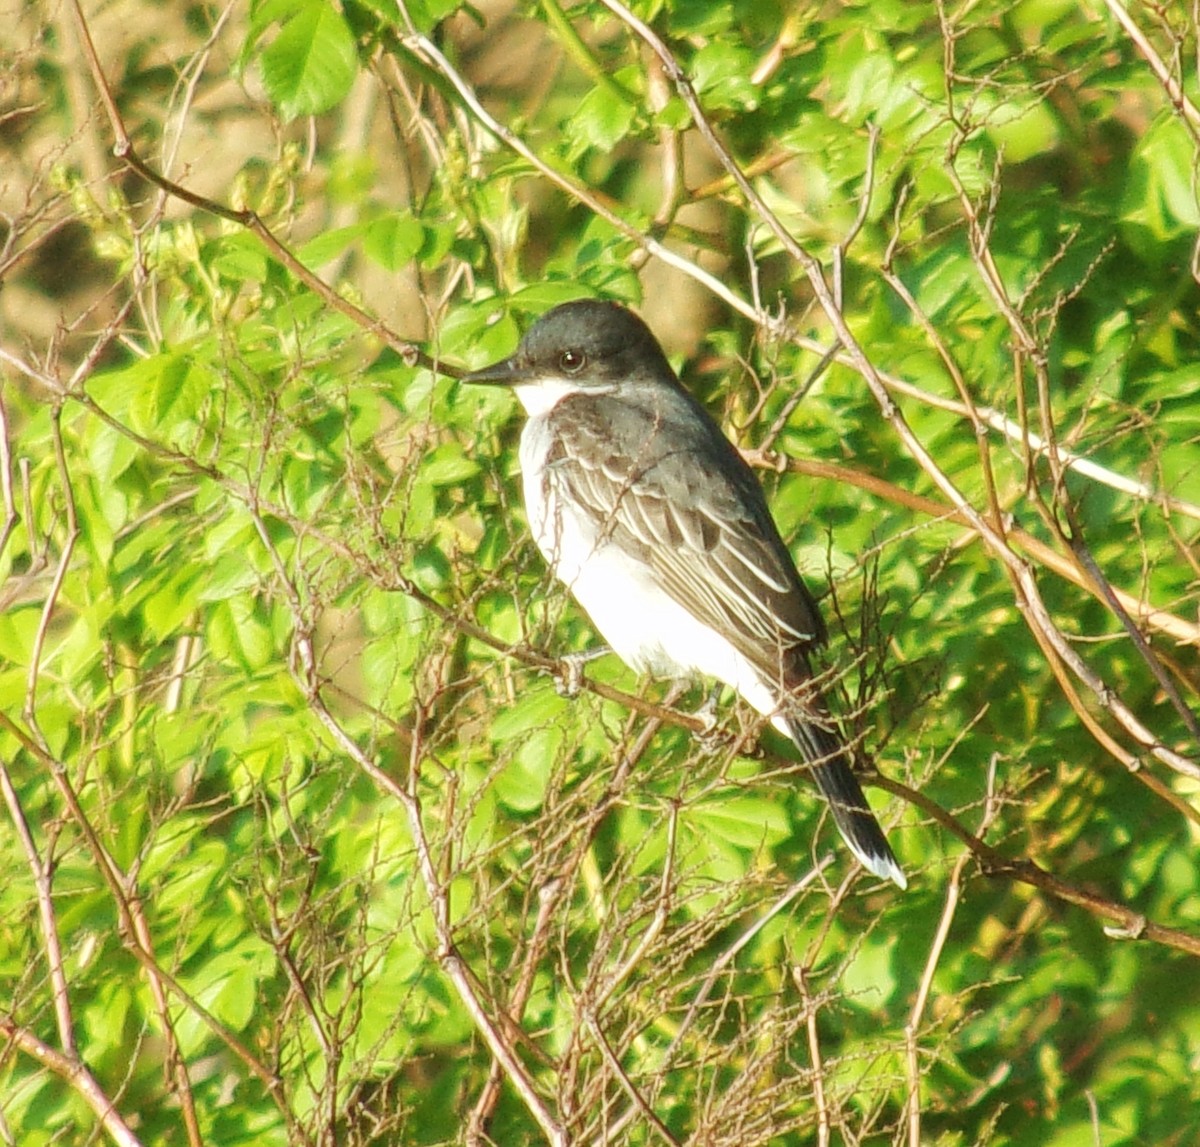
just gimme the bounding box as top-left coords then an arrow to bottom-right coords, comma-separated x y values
463,299 -> 676,403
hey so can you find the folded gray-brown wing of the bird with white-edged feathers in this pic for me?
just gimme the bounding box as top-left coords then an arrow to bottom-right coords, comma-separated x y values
546,394 -> 826,681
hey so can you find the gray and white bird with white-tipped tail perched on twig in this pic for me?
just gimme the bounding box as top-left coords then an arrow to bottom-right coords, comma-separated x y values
462,299 -> 907,888
